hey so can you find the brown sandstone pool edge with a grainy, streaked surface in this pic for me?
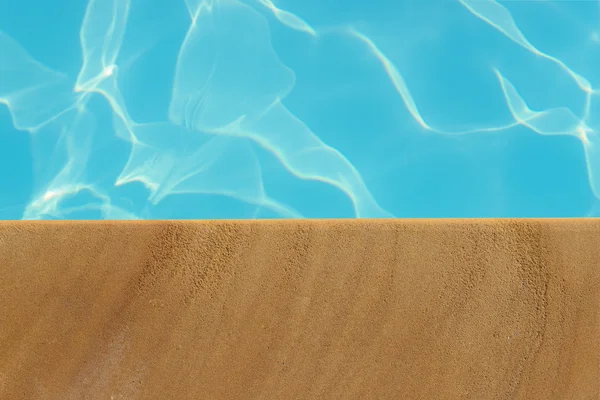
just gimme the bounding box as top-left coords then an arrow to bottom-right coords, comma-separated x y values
0,219 -> 600,400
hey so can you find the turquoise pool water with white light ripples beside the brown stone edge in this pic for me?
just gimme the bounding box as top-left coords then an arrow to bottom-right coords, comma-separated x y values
0,0 -> 600,219
